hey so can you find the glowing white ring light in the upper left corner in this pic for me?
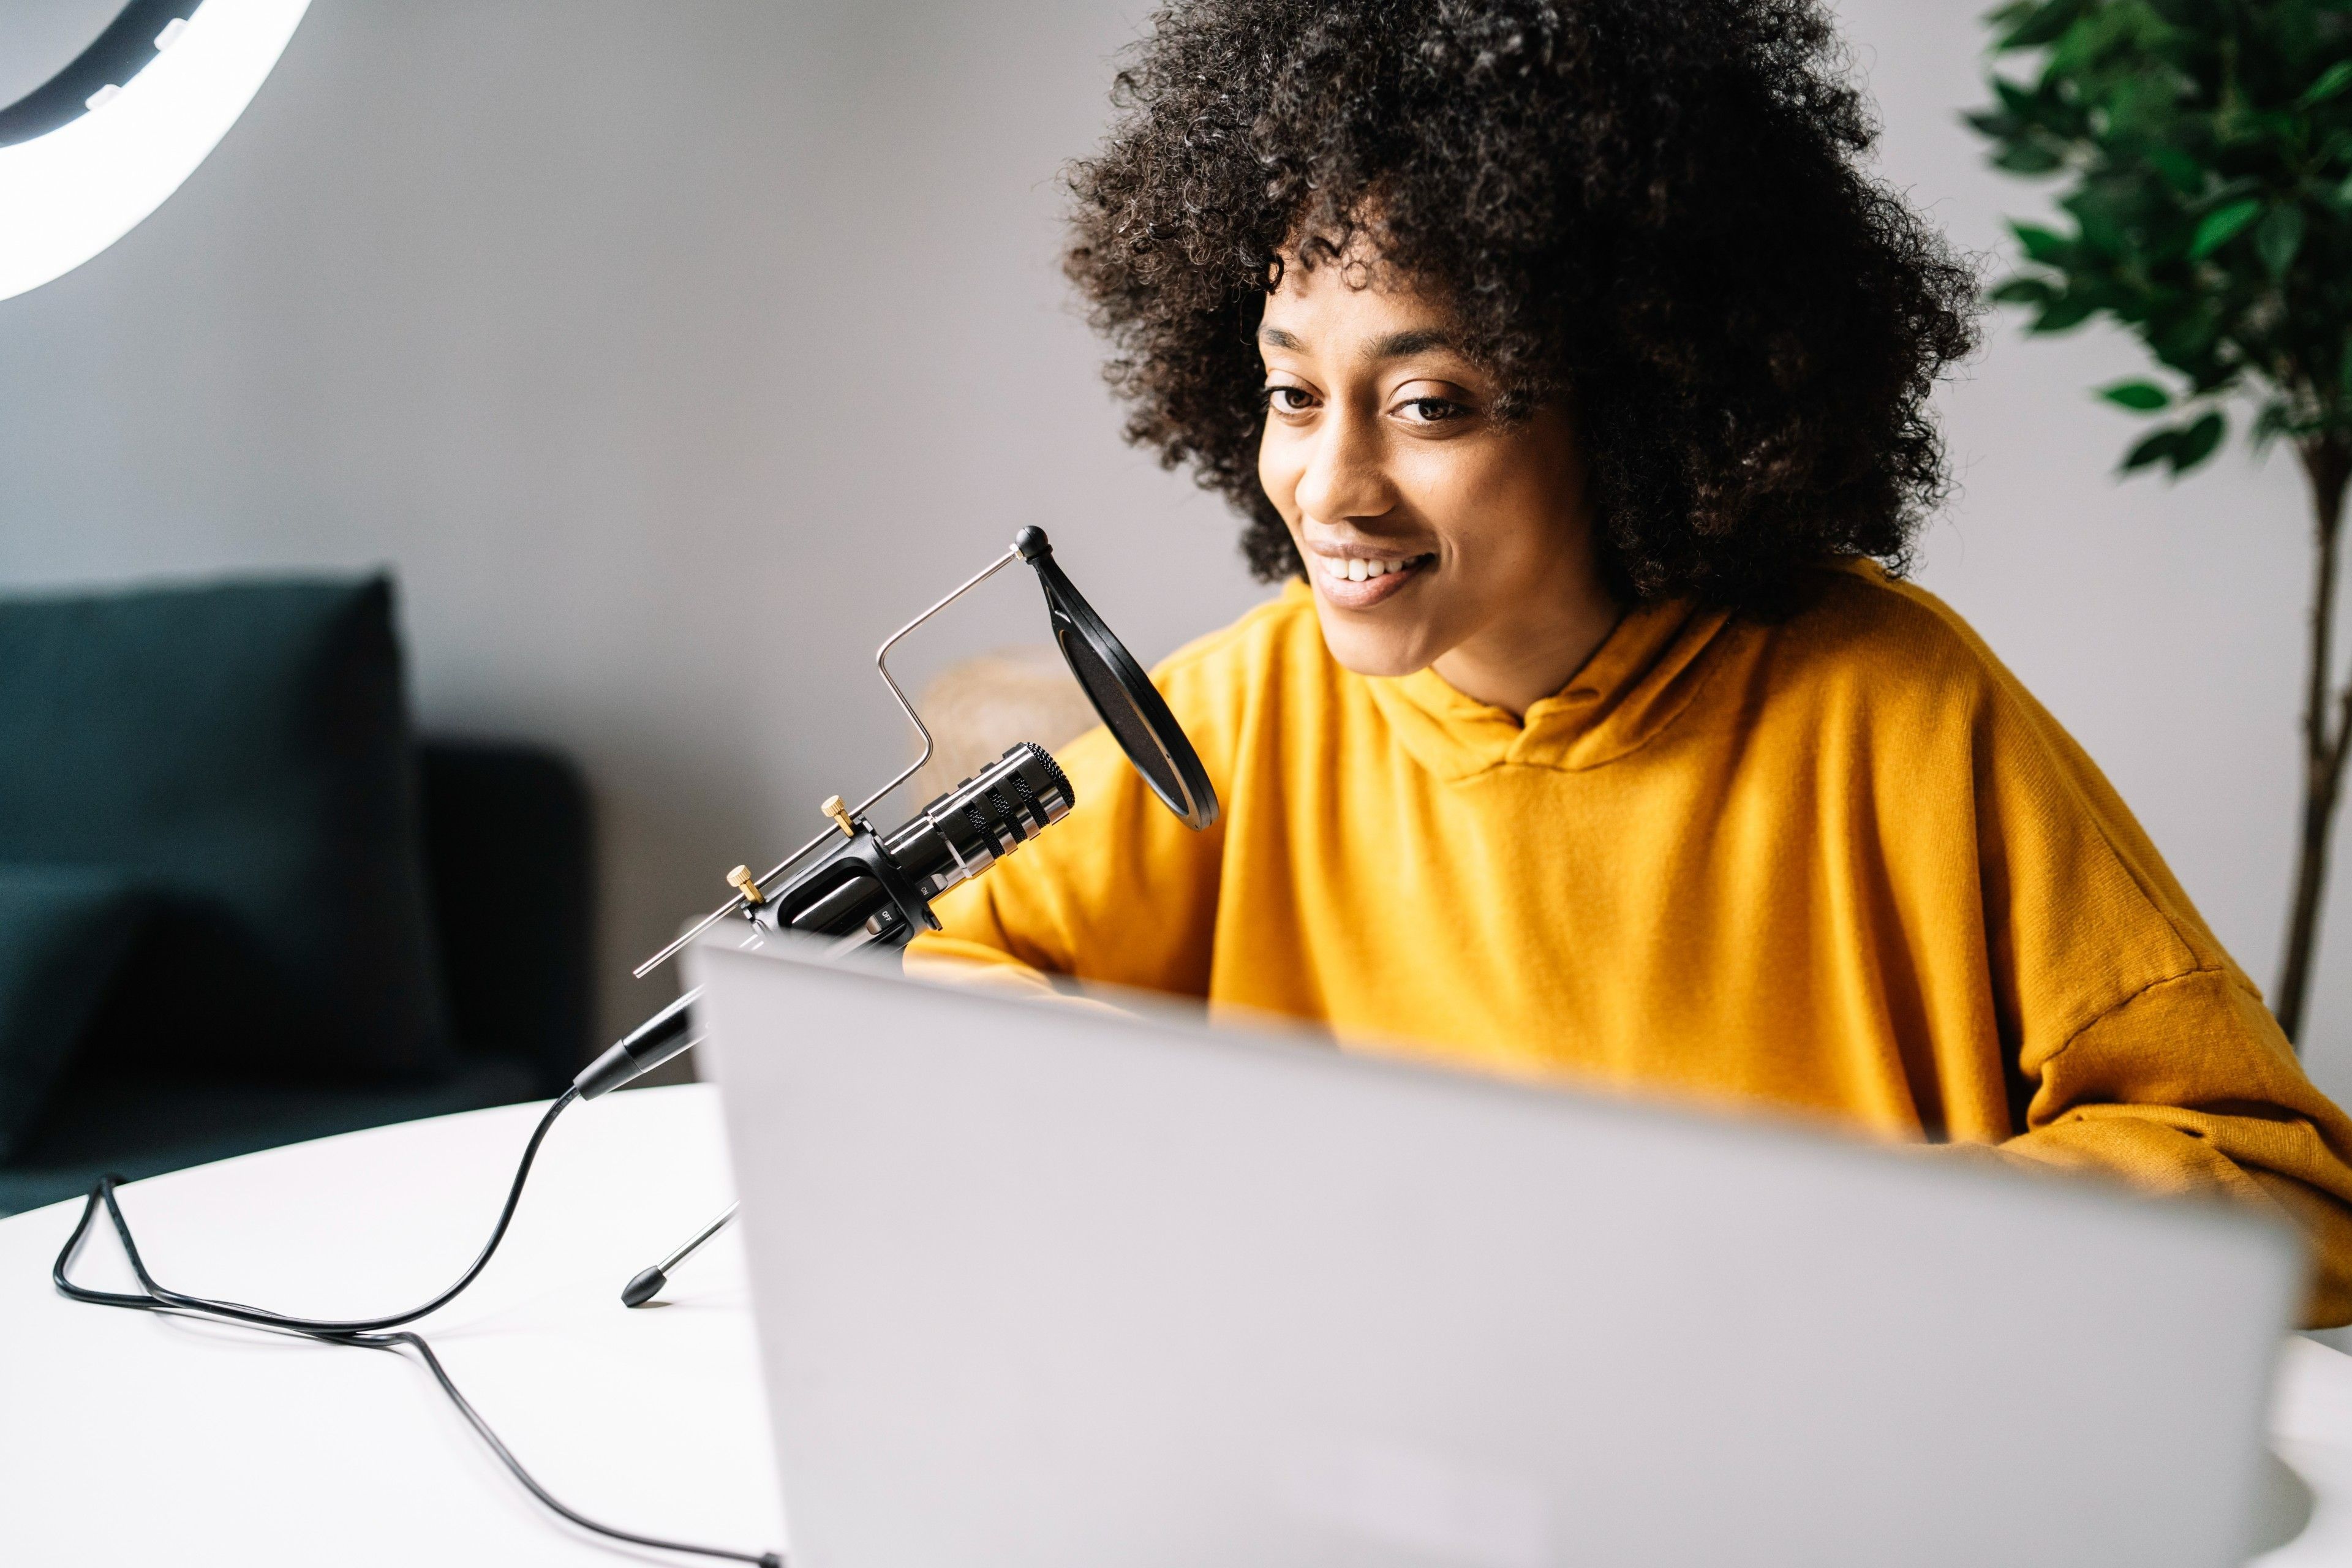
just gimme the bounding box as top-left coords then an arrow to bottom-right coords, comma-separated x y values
0,0 -> 311,298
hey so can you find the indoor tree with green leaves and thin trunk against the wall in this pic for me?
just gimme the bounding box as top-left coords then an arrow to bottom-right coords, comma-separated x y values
1969,0 -> 2352,1039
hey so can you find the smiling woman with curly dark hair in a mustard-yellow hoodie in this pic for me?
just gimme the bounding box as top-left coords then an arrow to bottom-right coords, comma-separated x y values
915,0 -> 2352,1324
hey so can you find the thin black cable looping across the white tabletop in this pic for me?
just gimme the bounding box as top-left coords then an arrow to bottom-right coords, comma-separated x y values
50,1088 -> 783,1568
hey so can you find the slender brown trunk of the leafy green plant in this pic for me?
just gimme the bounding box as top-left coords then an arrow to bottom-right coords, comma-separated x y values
2272,437 -> 2352,1041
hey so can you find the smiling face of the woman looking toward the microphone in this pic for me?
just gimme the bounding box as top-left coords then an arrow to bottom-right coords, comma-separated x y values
1258,256 -> 1618,712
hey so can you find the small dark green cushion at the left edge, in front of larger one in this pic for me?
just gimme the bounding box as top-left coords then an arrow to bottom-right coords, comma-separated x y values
0,865 -> 139,1161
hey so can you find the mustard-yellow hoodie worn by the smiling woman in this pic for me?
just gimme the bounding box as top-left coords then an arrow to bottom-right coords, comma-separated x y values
910,564 -> 2352,1324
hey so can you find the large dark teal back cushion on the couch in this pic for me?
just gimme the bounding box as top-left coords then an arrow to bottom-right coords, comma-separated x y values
0,578 -> 451,1079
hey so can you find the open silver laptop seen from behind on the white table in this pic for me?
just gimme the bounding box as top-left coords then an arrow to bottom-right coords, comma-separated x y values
689,938 -> 2302,1568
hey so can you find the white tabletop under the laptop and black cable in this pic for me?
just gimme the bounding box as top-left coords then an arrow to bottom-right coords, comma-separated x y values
13,1086 -> 2352,1568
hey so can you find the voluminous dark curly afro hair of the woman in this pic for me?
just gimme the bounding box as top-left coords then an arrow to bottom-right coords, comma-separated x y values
1066,0 -> 1976,614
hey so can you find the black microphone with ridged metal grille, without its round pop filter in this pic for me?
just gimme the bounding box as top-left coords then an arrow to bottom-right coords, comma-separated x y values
571,741 -> 1077,1100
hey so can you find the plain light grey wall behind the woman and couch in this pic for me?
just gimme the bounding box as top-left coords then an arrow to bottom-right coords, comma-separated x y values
0,0 -> 2352,1096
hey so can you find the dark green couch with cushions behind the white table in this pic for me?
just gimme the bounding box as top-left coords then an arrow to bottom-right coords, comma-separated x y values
0,578 -> 593,1213
